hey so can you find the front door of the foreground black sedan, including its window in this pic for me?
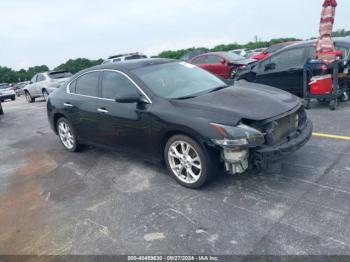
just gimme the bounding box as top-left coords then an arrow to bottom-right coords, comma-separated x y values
96,71 -> 150,155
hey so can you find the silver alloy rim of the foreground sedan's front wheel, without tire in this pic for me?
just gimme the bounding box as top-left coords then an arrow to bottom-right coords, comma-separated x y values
168,141 -> 203,184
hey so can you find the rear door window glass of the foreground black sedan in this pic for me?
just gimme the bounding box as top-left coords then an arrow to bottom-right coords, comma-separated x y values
75,72 -> 100,97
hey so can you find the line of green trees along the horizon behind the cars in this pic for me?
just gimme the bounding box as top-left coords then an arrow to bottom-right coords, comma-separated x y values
0,29 -> 350,83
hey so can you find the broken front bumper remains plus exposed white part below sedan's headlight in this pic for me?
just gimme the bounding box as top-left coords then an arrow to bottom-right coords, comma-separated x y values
221,121 -> 313,174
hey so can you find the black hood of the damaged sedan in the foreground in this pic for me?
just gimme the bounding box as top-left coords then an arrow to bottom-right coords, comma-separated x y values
174,81 -> 301,124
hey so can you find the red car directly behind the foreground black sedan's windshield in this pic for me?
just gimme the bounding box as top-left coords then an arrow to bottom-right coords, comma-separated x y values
189,52 -> 256,79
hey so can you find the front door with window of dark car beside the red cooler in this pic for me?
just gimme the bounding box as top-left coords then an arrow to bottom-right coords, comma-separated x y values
256,47 -> 307,96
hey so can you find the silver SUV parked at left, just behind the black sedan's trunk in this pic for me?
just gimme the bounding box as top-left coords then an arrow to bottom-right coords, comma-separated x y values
24,71 -> 72,103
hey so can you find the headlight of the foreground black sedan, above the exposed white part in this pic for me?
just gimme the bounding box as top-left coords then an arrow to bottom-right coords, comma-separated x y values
210,123 -> 265,148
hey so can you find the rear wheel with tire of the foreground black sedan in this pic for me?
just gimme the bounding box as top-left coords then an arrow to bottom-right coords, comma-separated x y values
56,117 -> 80,152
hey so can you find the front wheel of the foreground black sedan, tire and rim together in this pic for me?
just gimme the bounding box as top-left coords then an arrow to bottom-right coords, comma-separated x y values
164,135 -> 215,189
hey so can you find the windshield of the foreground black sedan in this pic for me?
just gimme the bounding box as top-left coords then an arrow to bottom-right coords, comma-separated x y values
132,62 -> 227,99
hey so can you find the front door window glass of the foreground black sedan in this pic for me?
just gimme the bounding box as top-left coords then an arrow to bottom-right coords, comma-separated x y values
102,72 -> 135,99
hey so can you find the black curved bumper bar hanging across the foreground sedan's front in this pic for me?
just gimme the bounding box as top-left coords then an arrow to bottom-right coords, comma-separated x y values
252,121 -> 313,168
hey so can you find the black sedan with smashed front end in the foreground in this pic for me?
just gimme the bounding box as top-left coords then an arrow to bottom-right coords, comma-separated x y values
47,59 -> 312,188
